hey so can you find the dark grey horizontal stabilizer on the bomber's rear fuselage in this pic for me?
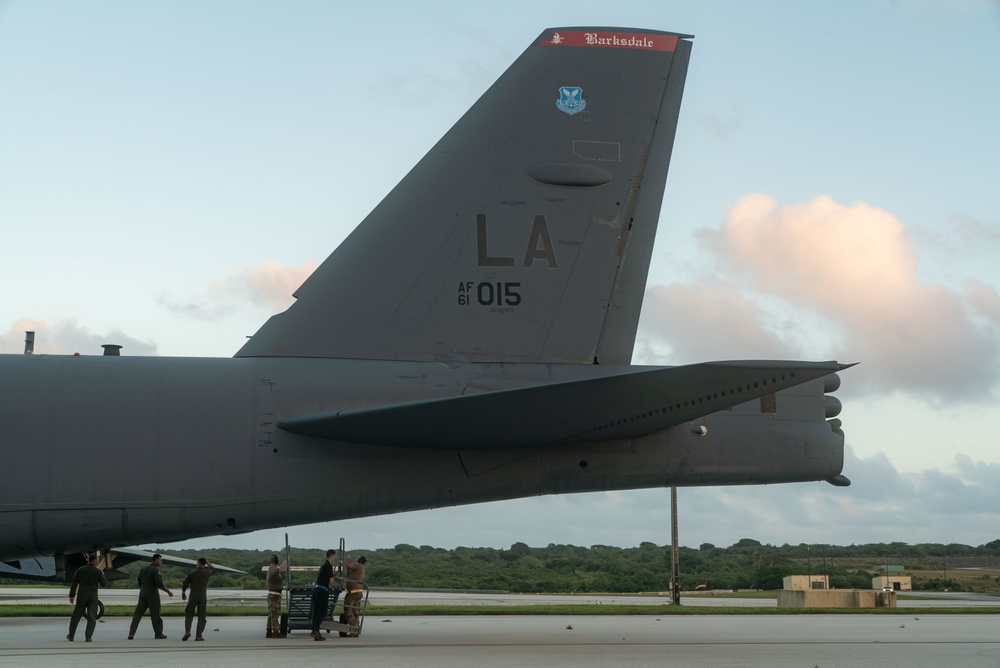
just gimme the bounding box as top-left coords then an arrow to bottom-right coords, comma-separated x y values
278,361 -> 851,449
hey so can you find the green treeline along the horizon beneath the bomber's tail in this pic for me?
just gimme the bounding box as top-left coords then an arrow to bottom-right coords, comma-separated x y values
119,538 -> 1000,593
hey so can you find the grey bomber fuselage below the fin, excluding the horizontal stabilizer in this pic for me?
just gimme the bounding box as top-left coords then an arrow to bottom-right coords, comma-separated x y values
0,355 -> 843,559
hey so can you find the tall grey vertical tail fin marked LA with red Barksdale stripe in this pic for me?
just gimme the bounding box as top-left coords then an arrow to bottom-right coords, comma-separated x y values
237,28 -> 691,364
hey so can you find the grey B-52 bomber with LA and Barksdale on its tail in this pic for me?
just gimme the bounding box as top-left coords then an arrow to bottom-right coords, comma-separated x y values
0,27 -> 849,576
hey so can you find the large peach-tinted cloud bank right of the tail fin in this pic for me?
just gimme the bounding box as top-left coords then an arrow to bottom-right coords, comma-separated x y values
643,194 -> 1000,402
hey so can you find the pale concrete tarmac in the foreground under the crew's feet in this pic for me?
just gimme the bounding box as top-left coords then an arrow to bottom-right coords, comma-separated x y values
0,607 -> 1000,668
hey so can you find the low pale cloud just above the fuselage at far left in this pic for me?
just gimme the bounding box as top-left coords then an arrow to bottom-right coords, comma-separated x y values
0,318 -> 157,355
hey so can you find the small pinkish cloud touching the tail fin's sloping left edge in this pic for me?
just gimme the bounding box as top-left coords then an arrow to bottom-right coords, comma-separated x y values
157,260 -> 318,320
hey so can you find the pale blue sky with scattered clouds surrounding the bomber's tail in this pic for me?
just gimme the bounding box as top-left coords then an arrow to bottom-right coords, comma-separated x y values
0,0 -> 1000,549
